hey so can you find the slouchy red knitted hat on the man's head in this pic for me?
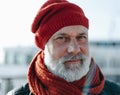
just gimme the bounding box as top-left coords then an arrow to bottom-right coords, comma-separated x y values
32,0 -> 89,49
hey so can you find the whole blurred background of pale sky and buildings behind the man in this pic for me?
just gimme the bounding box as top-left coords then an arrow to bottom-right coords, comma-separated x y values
0,0 -> 120,95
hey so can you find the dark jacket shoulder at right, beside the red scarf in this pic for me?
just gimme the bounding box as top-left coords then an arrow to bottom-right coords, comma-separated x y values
102,80 -> 120,95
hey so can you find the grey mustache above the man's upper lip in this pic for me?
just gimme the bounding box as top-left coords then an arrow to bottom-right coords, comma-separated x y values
60,53 -> 87,62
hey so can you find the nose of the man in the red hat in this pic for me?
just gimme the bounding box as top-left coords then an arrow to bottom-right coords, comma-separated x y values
68,39 -> 80,54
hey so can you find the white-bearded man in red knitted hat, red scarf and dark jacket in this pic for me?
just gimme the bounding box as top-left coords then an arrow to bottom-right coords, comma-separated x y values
8,0 -> 120,95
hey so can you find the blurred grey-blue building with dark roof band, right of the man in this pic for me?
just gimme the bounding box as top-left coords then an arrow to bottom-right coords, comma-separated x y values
90,41 -> 120,83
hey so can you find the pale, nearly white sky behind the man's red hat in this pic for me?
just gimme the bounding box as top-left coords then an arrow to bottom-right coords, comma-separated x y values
0,0 -> 120,49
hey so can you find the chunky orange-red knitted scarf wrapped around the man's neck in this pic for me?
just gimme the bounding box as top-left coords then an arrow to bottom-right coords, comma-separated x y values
28,52 -> 105,95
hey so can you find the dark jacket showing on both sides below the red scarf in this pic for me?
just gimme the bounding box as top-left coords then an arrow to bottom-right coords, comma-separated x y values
7,80 -> 120,95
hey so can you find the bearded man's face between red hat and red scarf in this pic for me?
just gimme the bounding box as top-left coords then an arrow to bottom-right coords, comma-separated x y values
44,25 -> 90,81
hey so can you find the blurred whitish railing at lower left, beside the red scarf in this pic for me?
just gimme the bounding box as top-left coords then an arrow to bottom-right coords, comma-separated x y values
0,65 -> 27,95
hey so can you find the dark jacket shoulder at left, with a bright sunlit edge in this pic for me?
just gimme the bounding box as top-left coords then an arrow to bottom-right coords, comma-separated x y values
7,83 -> 33,95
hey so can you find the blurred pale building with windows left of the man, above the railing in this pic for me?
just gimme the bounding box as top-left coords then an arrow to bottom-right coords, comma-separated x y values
4,46 -> 38,65
